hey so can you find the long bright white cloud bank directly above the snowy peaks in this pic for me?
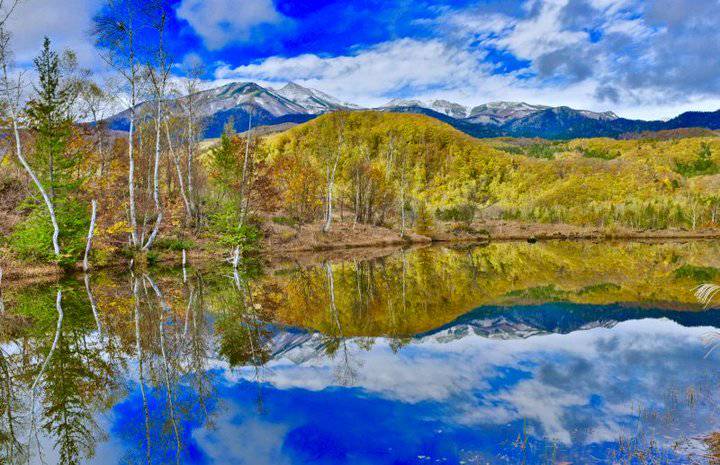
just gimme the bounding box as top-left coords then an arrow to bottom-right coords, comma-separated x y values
215,35 -> 640,115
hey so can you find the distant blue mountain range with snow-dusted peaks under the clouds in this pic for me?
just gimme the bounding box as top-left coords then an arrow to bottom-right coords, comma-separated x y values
108,82 -> 720,139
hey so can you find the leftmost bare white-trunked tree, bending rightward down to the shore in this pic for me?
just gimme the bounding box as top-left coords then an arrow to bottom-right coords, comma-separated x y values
0,28 -> 60,258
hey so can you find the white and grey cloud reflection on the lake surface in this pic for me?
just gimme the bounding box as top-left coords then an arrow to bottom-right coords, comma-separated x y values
226,319 -> 716,446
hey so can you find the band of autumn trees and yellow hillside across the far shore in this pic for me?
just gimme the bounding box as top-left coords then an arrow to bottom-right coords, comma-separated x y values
0,103 -> 720,272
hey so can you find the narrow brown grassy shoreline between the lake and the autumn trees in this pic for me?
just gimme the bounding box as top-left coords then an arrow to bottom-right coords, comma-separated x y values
0,222 -> 720,285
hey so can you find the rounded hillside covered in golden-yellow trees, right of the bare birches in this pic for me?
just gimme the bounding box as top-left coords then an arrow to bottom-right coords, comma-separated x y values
267,112 -> 720,229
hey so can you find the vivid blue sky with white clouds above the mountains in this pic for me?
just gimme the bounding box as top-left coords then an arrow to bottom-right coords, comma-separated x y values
5,0 -> 720,118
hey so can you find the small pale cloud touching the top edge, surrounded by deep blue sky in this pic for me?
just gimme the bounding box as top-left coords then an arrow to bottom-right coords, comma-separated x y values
177,0 -> 284,50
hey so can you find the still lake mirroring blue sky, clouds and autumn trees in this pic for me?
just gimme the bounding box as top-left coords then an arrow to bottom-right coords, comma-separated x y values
0,241 -> 720,464
